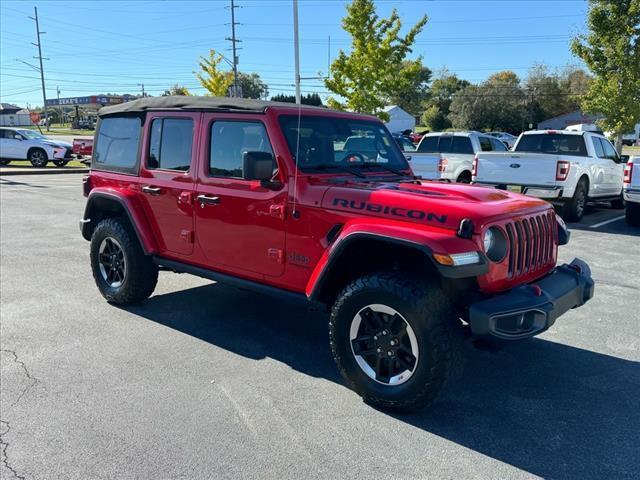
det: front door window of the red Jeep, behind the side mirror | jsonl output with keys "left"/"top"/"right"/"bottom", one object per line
{"left": 209, "top": 121, "right": 275, "bottom": 178}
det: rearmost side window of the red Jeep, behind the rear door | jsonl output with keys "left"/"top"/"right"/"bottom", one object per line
{"left": 93, "top": 117, "right": 141, "bottom": 172}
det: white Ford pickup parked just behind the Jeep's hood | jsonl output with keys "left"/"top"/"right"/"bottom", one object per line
{"left": 473, "top": 130, "right": 628, "bottom": 222}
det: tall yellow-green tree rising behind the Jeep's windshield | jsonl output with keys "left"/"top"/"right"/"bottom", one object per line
{"left": 325, "top": 0, "right": 427, "bottom": 120}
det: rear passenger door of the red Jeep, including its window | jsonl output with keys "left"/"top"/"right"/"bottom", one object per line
{"left": 140, "top": 112, "right": 201, "bottom": 256}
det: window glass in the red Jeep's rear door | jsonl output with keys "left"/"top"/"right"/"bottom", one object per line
{"left": 147, "top": 118, "right": 193, "bottom": 172}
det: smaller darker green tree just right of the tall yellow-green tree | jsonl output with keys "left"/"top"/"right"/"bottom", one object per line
{"left": 387, "top": 59, "right": 431, "bottom": 116}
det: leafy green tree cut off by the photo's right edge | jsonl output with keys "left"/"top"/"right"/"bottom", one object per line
{"left": 571, "top": 0, "right": 640, "bottom": 150}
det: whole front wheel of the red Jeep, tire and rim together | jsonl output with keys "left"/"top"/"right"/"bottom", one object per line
{"left": 329, "top": 271, "right": 461, "bottom": 412}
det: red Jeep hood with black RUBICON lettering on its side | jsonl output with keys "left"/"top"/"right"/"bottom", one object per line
{"left": 322, "top": 182, "right": 550, "bottom": 230}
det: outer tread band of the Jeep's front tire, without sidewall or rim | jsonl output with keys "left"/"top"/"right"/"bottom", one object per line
{"left": 329, "top": 270, "right": 463, "bottom": 413}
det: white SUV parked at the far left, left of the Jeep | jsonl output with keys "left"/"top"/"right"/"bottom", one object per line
{"left": 0, "top": 127, "right": 72, "bottom": 167}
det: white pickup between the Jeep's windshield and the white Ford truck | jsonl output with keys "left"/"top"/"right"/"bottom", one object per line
{"left": 411, "top": 132, "right": 507, "bottom": 183}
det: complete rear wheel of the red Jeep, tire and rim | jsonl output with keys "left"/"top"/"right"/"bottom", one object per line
{"left": 91, "top": 218, "right": 158, "bottom": 305}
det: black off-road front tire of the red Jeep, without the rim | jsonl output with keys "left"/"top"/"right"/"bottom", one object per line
{"left": 329, "top": 271, "right": 463, "bottom": 413}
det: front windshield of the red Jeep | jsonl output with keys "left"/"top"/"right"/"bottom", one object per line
{"left": 279, "top": 115, "right": 409, "bottom": 172}
